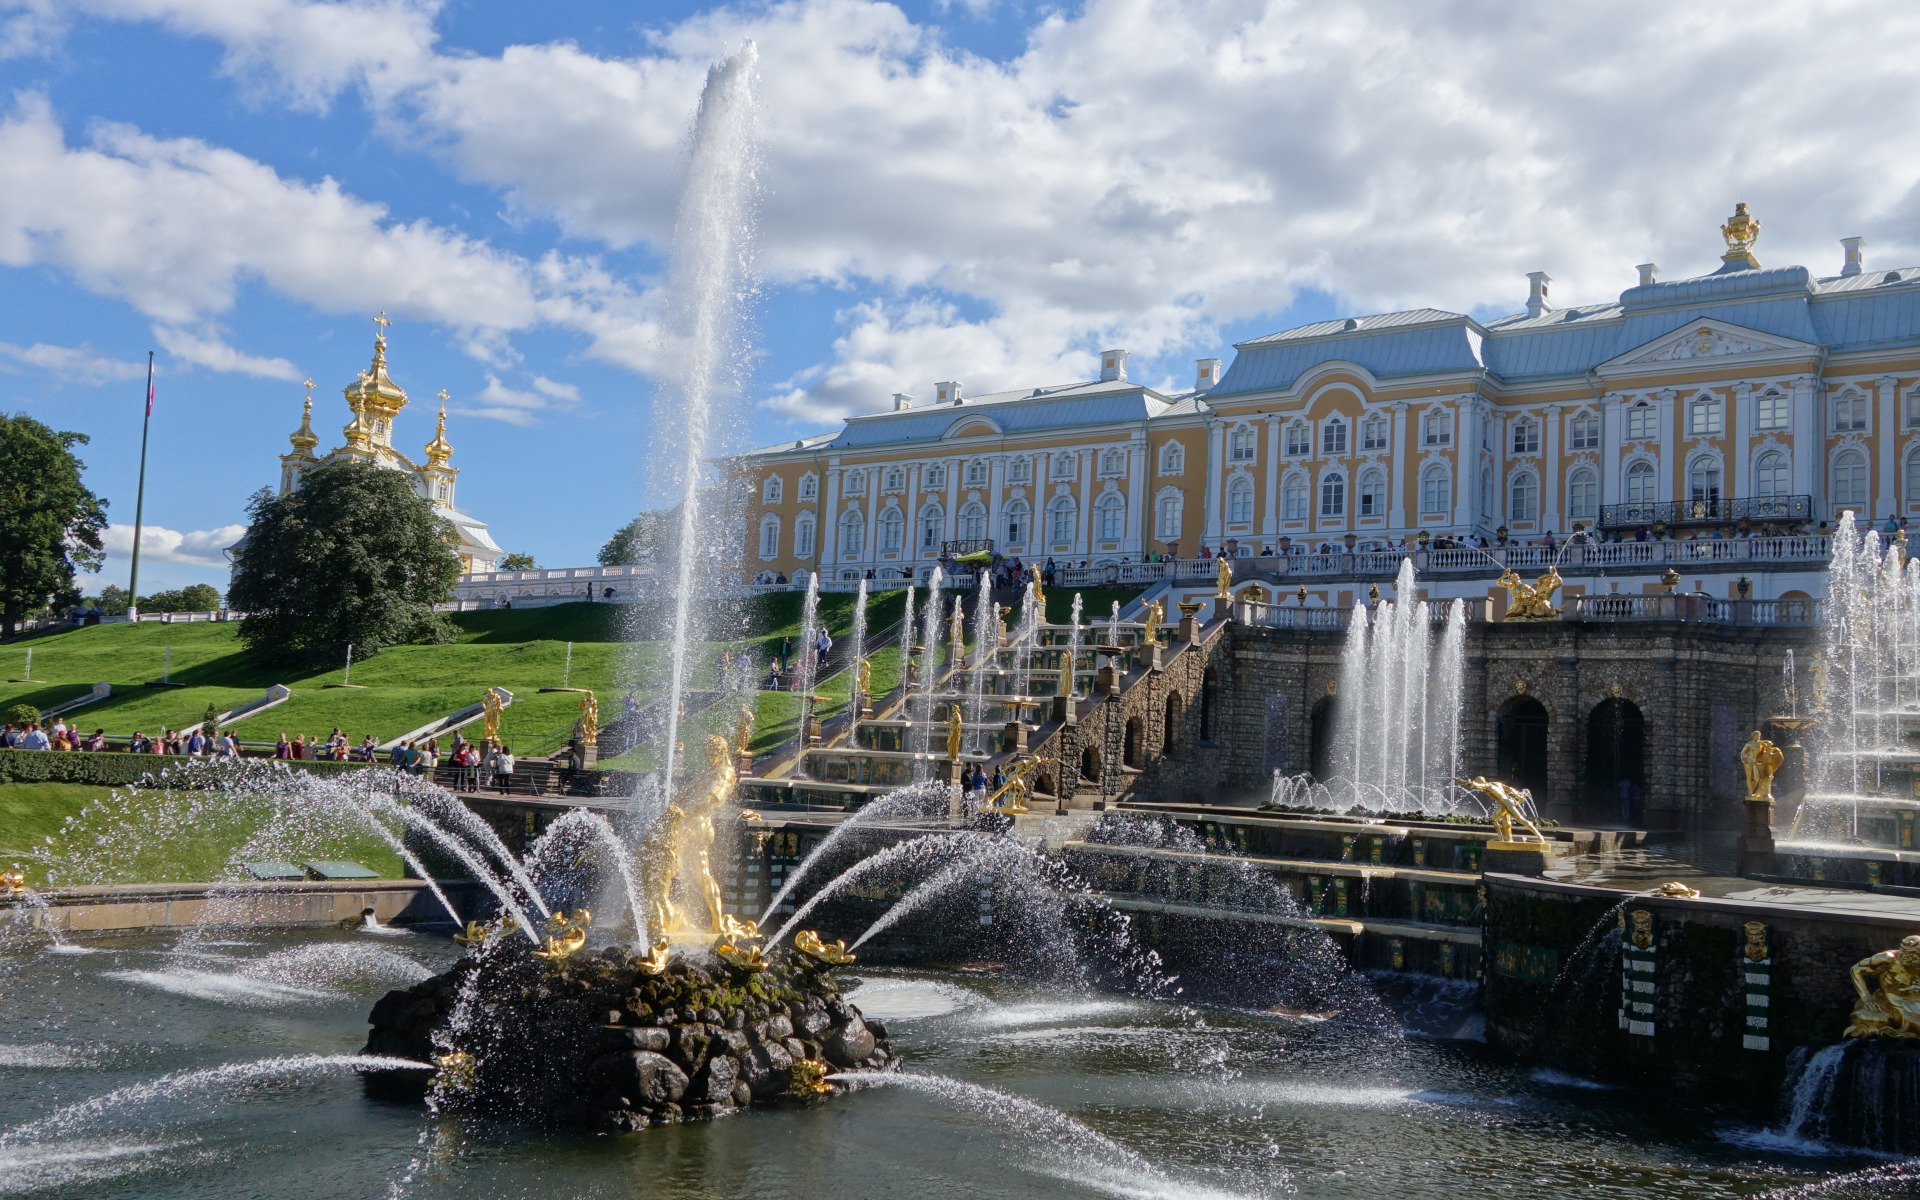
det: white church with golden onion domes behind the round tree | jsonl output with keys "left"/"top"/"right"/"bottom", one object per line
{"left": 280, "top": 313, "right": 503, "bottom": 572}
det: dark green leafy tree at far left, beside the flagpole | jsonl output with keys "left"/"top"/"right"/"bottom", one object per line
{"left": 0, "top": 413, "right": 108, "bottom": 634}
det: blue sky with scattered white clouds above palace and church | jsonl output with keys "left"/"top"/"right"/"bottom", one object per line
{"left": 0, "top": 0, "right": 1920, "bottom": 589}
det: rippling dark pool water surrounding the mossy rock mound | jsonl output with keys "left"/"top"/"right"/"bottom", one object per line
{"left": 0, "top": 931, "right": 1907, "bottom": 1200}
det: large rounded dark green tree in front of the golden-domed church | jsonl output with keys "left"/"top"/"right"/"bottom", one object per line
{"left": 227, "top": 463, "right": 461, "bottom": 666}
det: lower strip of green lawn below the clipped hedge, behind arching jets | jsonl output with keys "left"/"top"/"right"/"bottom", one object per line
{"left": 0, "top": 771, "right": 403, "bottom": 885}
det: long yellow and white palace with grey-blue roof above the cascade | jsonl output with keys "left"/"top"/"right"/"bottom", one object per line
{"left": 729, "top": 204, "right": 1920, "bottom": 595}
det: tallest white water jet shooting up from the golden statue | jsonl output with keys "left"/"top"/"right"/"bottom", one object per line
{"left": 649, "top": 42, "right": 758, "bottom": 797}
